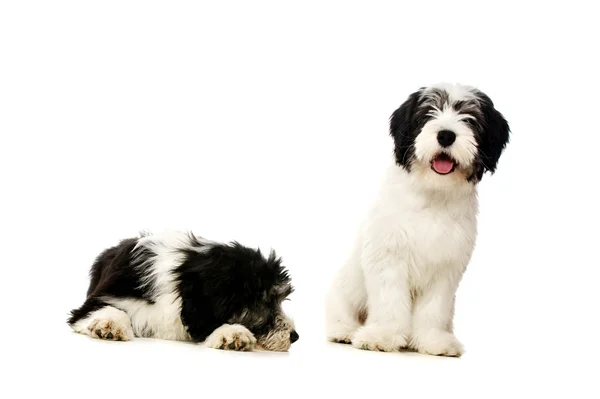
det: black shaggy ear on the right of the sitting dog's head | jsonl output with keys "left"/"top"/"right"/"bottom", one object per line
{"left": 479, "top": 93, "right": 510, "bottom": 173}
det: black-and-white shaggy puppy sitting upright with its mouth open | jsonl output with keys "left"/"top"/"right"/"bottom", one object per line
{"left": 325, "top": 84, "right": 511, "bottom": 356}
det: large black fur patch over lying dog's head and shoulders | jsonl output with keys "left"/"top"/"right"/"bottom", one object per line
{"left": 177, "top": 243, "right": 292, "bottom": 341}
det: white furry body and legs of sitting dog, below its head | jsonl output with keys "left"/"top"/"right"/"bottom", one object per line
{"left": 326, "top": 159, "right": 477, "bottom": 356}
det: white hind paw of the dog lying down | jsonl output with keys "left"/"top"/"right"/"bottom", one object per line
{"left": 70, "top": 305, "right": 134, "bottom": 341}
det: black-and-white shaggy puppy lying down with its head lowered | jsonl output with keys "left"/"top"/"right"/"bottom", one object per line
{"left": 67, "top": 231, "right": 299, "bottom": 351}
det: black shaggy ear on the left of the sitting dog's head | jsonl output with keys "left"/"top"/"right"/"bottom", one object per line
{"left": 390, "top": 90, "right": 421, "bottom": 169}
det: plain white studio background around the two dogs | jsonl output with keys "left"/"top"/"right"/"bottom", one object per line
{"left": 0, "top": 1, "right": 600, "bottom": 398}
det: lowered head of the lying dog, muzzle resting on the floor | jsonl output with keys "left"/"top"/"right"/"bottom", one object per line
{"left": 223, "top": 246, "right": 299, "bottom": 351}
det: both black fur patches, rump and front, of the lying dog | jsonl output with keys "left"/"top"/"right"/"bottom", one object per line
{"left": 68, "top": 234, "right": 293, "bottom": 342}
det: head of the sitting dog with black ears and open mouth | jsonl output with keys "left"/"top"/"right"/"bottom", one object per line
{"left": 390, "top": 84, "right": 510, "bottom": 188}
